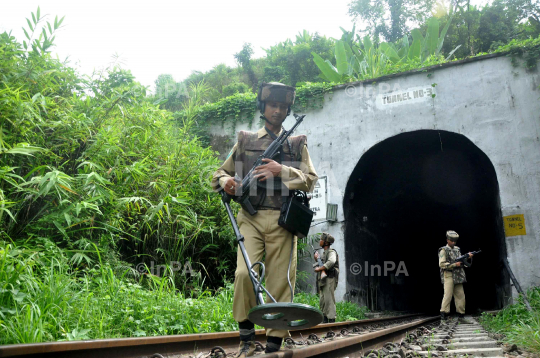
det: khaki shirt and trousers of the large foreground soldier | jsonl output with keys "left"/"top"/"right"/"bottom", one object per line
{"left": 212, "top": 128, "right": 318, "bottom": 338}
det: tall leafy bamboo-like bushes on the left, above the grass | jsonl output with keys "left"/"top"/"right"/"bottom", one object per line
{"left": 0, "top": 10, "right": 236, "bottom": 289}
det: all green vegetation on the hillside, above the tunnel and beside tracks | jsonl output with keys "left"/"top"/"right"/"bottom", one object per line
{"left": 0, "top": 0, "right": 540, "bottom": 347}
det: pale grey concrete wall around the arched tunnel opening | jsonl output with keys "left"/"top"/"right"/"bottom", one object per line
{"left": 211, "top": 56, "right": 540, "bottom": 309}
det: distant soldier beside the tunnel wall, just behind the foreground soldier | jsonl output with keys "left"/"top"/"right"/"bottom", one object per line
{"left": 313, "top": 232, "right": 339, "bottom": 323}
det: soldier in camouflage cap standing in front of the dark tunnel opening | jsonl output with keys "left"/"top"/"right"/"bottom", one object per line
{"left": 439, "top": 230, "right": 473, "bottom": 321}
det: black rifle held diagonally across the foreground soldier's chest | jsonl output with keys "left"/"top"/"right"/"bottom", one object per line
{"left": 221, "top": 114, "right": 306, "bottom": 215}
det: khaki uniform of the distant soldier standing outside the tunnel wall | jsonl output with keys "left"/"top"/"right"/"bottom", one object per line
{"left": 313, "top": 249, "right": 339, "bottom": 319}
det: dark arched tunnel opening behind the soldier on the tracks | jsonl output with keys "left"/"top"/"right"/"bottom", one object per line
{"left": 343, "top": 130, "right": 511, "bottom": 313}
